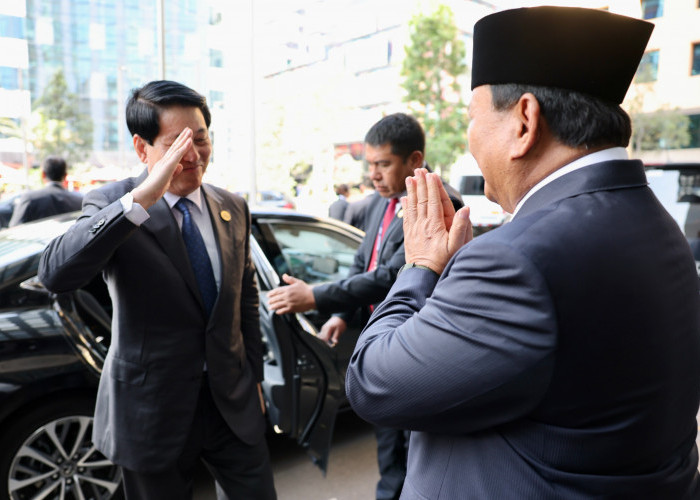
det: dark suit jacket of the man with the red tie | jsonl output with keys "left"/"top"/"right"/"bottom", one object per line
{"left": 313, "top": 183, "right": 463, "bottom": 322}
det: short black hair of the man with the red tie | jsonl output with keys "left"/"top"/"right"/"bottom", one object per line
{"left": 365, "top": 113, "right": 425, "bottom": 160}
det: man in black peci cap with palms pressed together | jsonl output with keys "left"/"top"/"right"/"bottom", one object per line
{"left": 346, "top": 7, "right": 700, "bottom": 500}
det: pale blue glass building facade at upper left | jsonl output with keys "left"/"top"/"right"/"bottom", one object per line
{"left": 0, "top": 0, "right": 221, "bottom": 162}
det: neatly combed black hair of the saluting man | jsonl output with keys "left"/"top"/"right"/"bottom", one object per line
{"left": 126, "top": 80, "right": 211, "bottom": 145}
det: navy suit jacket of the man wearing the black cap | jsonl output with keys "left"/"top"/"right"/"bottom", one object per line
{"left": 346, "top": 160, "right": 700, "bottom": 500}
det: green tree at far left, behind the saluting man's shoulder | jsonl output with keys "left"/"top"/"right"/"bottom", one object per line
{"left": 32, "top": 69, "right": 92, "bottom": 163}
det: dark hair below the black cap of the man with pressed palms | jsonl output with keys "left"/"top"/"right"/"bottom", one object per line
{"left": 491, "top": 83, "right": 632, "bottom": 149}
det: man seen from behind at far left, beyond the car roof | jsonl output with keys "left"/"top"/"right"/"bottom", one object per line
{"left": 9, "top": 156, "right": 83, "bottom": 227}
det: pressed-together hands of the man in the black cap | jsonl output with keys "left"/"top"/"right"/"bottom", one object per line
{"left": 401, "top": 168, "right": 473, "bottom": 274}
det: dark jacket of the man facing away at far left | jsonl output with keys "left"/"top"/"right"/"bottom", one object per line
{"left": 9, "top": 182, "right": 83, "bottom": 227}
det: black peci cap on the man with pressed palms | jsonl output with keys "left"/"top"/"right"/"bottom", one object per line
{"left": 472, "top": 7, "right": 654, "bottom": 104}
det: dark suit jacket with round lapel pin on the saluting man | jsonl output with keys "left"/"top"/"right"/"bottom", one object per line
{"left": 39, "top": 172, "right": 265, "bottom": 472}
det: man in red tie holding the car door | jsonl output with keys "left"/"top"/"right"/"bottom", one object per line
{"left": 268, "top": 113, "right": 462, "bottom": 500}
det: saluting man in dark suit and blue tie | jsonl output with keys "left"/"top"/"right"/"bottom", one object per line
{"left": 39, "top": 81, "right": 275, "bottom": 500}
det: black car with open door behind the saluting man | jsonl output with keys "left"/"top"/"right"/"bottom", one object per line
{"left": 0, "top": 211, "right": 363, "bottom": 500}
